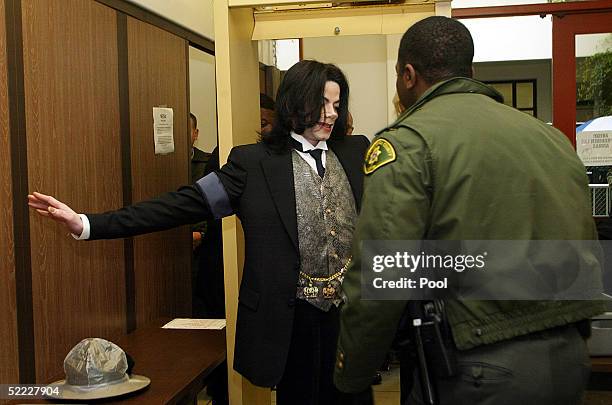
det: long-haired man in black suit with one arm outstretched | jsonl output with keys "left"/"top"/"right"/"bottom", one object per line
{"left": 28, "top": 60, "right": 369, "bottom": 405}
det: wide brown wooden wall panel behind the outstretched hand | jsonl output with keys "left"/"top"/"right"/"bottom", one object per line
{"left": 22, "top": 0, "right": 126, "bottom": 381}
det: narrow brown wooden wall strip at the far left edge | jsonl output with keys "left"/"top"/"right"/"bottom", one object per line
{"left": 0, "top": 0, "right": 19, "bottom": 384}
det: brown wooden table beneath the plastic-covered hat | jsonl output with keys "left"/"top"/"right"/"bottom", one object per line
{"left": 11, "top": 319, "right": 226, "bottom": 405}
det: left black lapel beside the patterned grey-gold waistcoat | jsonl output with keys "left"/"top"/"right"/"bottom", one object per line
{"left": 261, "top": 151, "right": 299, "bottom": 251}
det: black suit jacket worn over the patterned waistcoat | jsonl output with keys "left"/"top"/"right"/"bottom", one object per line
{"left": 88, "top": 136, "right": 368, "bottom": 387}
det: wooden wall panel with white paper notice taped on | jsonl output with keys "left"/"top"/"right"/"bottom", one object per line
{"left": 127, "top": 17, "right": 191, "bottom": 326}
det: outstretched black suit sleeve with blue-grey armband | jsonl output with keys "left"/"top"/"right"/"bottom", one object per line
{"left": 86, "top": 145, "right": 246, "bottom": 240}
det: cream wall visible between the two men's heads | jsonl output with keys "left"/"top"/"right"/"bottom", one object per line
{"left": 303, "top": 35, "right": 388, "bottom": 138}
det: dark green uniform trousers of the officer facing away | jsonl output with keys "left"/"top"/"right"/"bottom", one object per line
{"left": 407, "top": 325, "right": 591, "bottom": 405}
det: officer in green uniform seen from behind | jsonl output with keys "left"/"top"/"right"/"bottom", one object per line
{"left": 335, "top": 17, "right": 604, "bottom": 405}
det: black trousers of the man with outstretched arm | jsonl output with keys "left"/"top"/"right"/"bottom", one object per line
{"left": 276, "top": 299, "right": 340, "bottom": 405}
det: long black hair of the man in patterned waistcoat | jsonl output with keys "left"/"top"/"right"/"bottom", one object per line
{"left": 261, "top": 60, "right": 349, "bottom": 150}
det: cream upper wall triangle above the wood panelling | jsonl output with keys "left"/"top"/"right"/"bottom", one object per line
{"left": 128, "top": 0, "right": 215, "bottom": 40}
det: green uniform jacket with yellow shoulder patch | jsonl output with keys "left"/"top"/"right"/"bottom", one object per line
{"left": 335, "top": 78, "right": 604, "bottom": 392}
